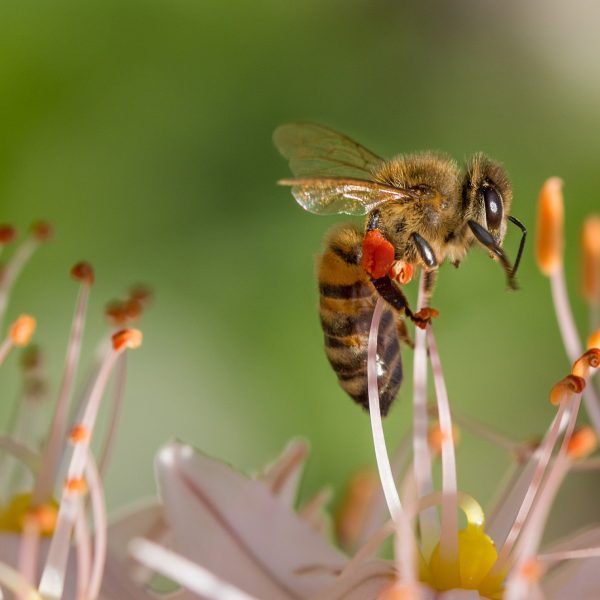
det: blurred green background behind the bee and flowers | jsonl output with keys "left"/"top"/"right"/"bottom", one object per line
{"left": 0, "top": 0, "right": 600, "bottom": 530}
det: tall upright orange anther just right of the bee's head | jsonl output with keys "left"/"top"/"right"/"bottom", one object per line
{"left": 536, "top": 177, "right": 564, "bottom": 275}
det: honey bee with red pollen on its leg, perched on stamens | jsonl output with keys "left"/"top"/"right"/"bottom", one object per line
{"left": 273, "top": 123, "right": 527, "bottom": 415}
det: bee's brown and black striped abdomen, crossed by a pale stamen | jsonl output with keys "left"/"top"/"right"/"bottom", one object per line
{"left": 318, "top": 225, "right": 402, "bottom": 415}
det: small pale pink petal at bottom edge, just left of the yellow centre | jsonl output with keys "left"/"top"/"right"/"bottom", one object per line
{"left": 311, "top": 560, "right": 395, "bottom": 600}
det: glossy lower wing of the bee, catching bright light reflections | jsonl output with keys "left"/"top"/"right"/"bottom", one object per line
{"left": 279, "top": 177, "right": 415, "bottom": 215}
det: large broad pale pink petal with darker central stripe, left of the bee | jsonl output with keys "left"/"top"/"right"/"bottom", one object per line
{"left": 157, "top": 443, "right": 346, "bottom": 600}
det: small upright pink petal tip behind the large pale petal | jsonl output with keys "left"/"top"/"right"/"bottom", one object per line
{"left": 257, "top": 439, "right": 308, "bottom": 507}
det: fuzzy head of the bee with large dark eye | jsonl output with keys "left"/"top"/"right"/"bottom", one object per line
{"left": 462, "top": 154, "right": 512, "bottom": 246}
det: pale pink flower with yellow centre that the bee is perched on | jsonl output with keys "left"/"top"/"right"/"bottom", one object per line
{"left": 122, "top": 179, "right": 600, "bottom": 600}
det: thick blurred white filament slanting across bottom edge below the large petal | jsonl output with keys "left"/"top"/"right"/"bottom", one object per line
{"left": 129, "top": 538, "right": 257, "bottom": 600}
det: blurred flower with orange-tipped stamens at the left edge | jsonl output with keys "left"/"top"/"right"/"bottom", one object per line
{"left": 0, "top": 222, "right": 142, "bottom": 600}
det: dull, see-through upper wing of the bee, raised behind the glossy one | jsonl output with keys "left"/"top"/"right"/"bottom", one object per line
{"left": 273, "top": 123, "right": 383, "bottom": 179}
